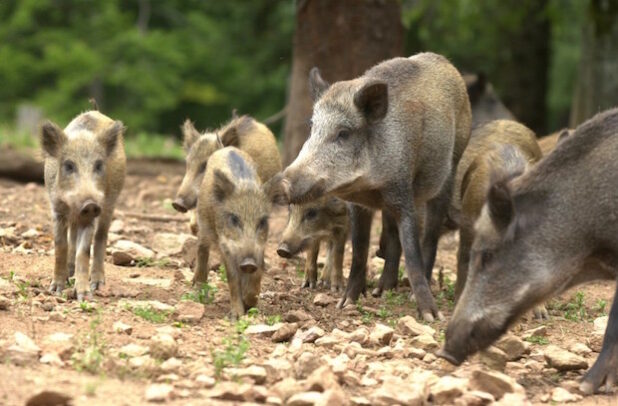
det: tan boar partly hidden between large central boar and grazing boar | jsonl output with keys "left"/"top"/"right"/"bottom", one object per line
{"left": 451, "top": 120, "right": 541, "bottom": 298}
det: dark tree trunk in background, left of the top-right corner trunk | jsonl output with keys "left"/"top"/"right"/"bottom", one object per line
{"left": 497, "top": 0, "right": 550, "bottom": 134}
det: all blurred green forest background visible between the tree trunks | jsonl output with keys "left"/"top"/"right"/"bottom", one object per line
{"left": 0, "top": 0, "right": 594, "bottom": 154}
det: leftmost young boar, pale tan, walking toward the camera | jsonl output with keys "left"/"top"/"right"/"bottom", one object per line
{"left": 40, "top": 111, "right": 126, "bottom": 301}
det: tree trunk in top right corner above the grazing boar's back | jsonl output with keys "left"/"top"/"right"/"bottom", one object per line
{"left": 569, "top": 0, "right": 618, "bottom": 128}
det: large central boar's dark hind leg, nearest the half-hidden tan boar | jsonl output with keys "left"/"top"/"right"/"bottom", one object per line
{"left": 421, "top": 176, "right": 453, "bottom": 281}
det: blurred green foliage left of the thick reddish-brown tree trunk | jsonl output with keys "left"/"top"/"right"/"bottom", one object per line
{"left": 0, "top": 0, "right": 294, "bottom": 136}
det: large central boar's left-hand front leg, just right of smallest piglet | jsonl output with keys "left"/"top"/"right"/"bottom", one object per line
{"left": 337, "top": 205, "right": 373, "bottom": 309}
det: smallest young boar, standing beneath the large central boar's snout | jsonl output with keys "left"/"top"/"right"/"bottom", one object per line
{"left": 277, "top": 197, "right": 348, "bottom": 292}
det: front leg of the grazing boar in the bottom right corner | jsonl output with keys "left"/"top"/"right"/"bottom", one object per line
{"left": 579, "top": 281, "right": 618, "bottom": 394}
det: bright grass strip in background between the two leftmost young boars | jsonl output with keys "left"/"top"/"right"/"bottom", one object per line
{"left": 124, "top": 133, "right": 185, "bottom": 160}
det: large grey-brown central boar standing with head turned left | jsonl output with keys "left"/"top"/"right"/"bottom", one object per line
{"left": 283, "top": 53, "right": 470, "bottom": 320}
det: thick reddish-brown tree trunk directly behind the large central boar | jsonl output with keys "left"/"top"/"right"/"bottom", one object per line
{"left": 283, "top": 0, "right": 404, "bottom": 165}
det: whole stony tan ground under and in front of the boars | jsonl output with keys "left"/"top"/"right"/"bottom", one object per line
{"left": 0, "top": 162, "right": 618, "bottom": 406}
